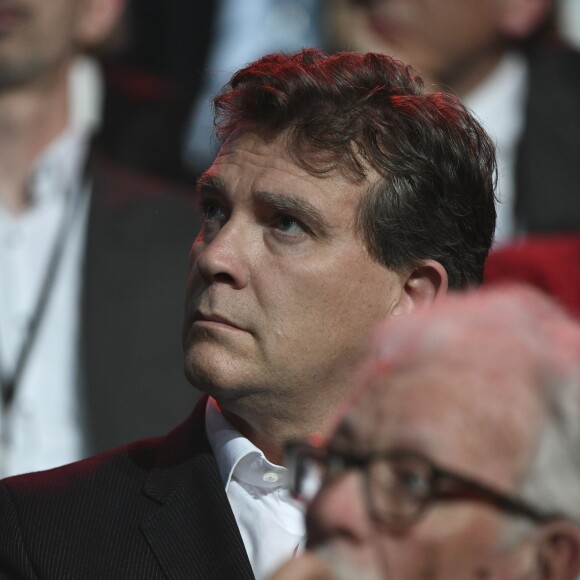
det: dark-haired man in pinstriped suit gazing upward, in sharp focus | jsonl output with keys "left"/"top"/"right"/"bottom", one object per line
{"left": 0, "top": 51, "right": 495, "bottom": 579}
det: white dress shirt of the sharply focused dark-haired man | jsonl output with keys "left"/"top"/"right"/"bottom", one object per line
{"left": 205, "top": 397, "right": 305, "bottom": 580}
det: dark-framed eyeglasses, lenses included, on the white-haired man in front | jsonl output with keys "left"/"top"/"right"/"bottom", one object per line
{"left": 285, "top": 443, "right": 569, "bottom": 527}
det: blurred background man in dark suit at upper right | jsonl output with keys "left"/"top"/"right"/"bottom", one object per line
{"left": 324, "top": 0, "right": 580, "bottom": 243}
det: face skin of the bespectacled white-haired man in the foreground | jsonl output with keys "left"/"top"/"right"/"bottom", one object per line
{"left": 308, "top": 363, "right": 539, "bottom": 580}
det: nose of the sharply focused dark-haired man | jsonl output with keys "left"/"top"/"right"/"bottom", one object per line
{"left": 192, "top": 222, "right": 249, "bottom": 289}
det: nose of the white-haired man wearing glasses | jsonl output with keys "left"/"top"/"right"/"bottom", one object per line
{"left": 306, "top": 472, "right": 371, "bottom": 548}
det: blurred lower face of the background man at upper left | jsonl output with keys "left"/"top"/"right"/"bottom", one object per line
{"left": 0, "top": 0, "right": 86, "bottom": 87}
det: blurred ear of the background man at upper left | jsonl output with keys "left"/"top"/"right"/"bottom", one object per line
{"left": 76, "top": 0, "right": 125, "bottom": 49}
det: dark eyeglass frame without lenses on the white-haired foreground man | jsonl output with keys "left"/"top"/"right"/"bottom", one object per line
{"left": 284, "top": 441, "right": 568, "bottom": 527}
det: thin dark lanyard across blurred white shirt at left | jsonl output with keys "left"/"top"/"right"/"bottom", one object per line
{"left": 0, "top": 163, "right": 89, "bottom": 414}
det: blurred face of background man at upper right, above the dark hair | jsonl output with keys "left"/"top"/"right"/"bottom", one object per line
{"left": 328, "top": 0, "right": 505, "bottom": 89}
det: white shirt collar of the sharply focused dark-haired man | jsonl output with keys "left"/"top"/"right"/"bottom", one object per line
{"left": 205, "top": 397, "right": 288, "bottom": 491}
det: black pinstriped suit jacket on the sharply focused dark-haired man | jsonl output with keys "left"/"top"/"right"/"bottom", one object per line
{"left": 0, "top": 399, "right": 254, "bottom": 580}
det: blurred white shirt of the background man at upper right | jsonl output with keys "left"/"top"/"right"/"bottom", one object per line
{"left": 464, "top": 52, "right": 528, "bottom": 245}
